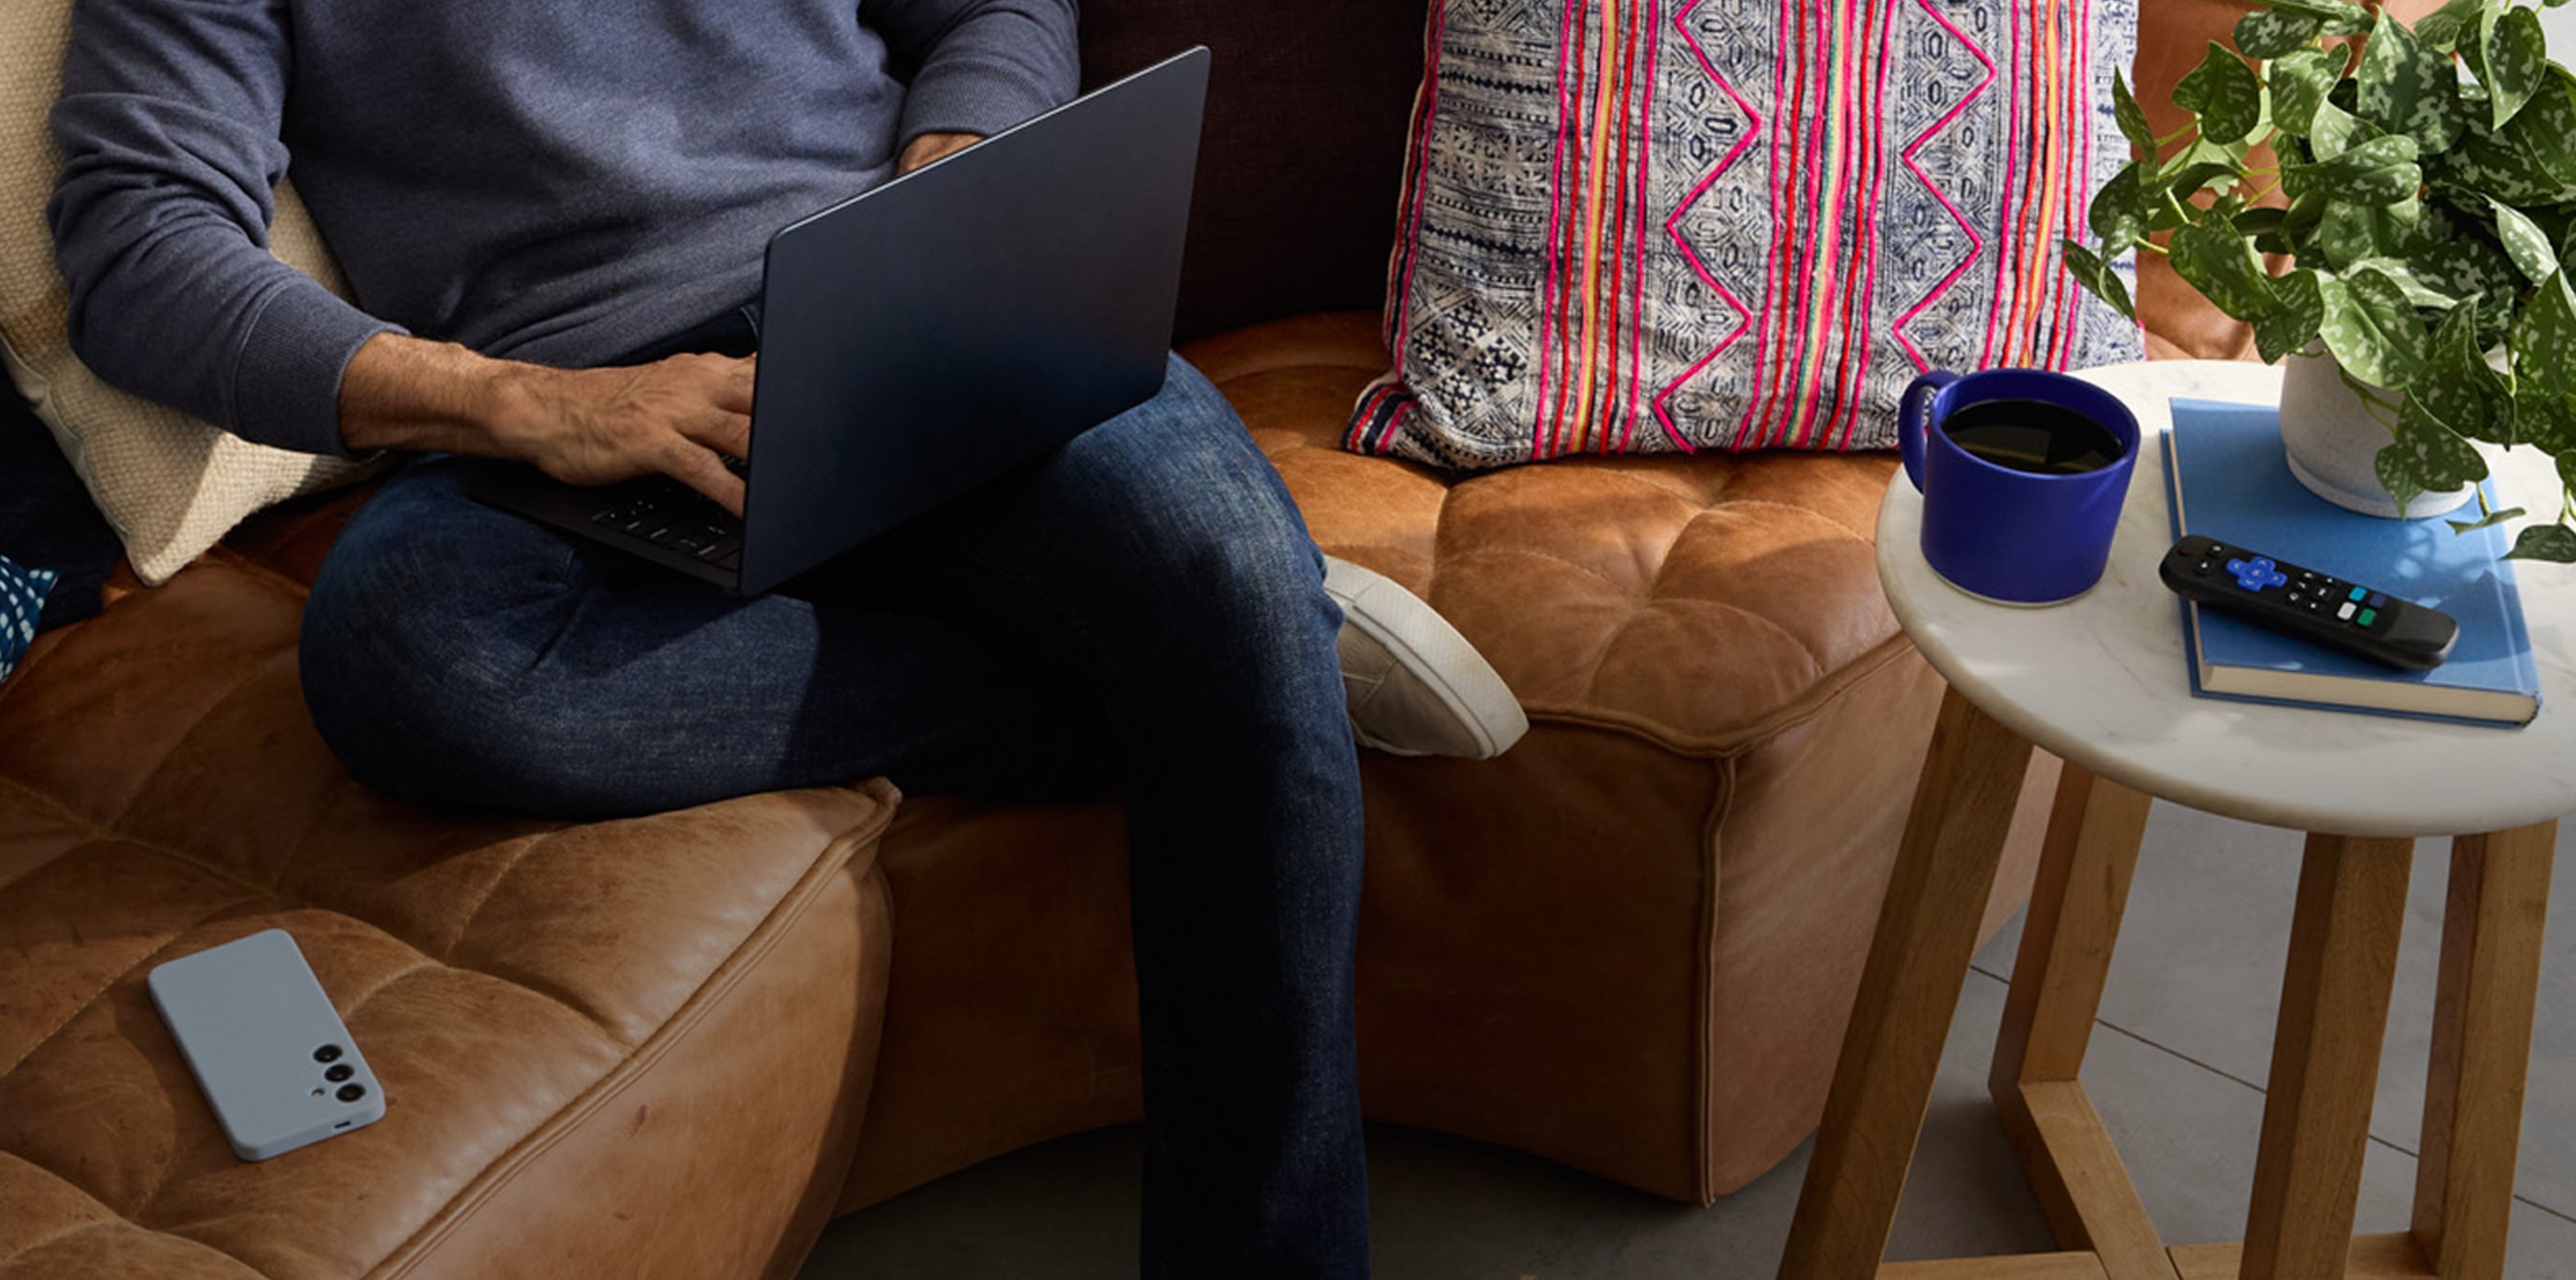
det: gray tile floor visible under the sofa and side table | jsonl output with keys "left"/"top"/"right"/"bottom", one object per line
{"left": 802, "top": 806, "right": 2576, "bottom": 1280}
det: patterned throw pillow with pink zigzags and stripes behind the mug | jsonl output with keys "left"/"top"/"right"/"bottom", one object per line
{"left": 1345, "top": 0, "right": 2140, "bottom": 469}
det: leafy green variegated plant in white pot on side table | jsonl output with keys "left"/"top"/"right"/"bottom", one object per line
{"left": 2066, "top": 0, "right": 2576, "bottom": 564}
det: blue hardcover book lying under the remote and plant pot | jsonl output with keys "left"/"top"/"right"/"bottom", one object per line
{"left": 2164, "top": 400, "right": 2540, "bottom": 726}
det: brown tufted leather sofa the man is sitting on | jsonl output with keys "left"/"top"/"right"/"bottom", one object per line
{"left": 0, "top": 0, "right": 2297, "bottom": 1278}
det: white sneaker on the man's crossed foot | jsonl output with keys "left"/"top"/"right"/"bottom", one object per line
{"left": 1324, "top": 556, "right": 1530, "bottom": 760}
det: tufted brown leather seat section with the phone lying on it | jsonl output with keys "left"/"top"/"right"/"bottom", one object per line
{"left": 0, "top": 561, "right": 894, "bottom": 1278}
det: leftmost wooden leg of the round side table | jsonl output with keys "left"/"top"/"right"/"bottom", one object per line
{"left": 1780, "top": 690, "right": 2030, "bottom": 1280}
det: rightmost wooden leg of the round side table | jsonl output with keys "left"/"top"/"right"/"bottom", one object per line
{"left": 2414, "top": 821, "right": 2558, "bottom": 1280}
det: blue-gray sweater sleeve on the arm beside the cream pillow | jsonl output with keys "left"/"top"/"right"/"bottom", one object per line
{"left": 47, "top": 0, "right": 397, "bottom": 456}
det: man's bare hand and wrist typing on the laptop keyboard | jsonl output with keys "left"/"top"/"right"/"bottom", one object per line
{"left": 340, "top": 335, "right": 755, "bottom": 515}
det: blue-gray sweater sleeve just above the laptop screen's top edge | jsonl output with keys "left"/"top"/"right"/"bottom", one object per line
{"left": 863, "top": 0, "right": 1080, "bottom": 147}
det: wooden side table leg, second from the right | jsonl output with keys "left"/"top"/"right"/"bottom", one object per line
{"left": 2239, "top": 834, "right": 2414, "bottom": 1280}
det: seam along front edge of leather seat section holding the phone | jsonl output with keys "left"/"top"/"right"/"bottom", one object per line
{"left": 366, "top": 785, "right": 899, "bottom": 1280}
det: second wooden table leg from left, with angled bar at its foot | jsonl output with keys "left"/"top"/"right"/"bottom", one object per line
{"left": 1989, "top": 765, "right": 2174, "bottom": 1280}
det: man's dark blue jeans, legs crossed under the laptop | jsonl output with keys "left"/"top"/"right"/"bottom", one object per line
{"left": 301, "top": 342, "right": 1368, "bottom": 1280}
